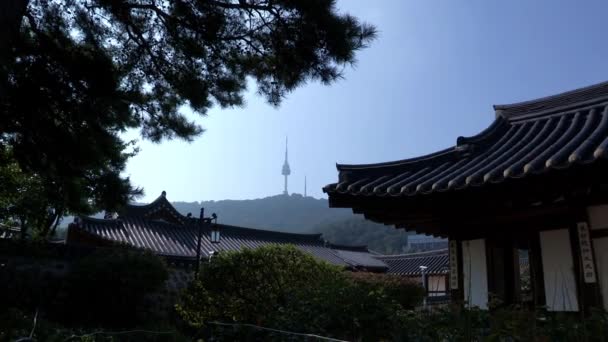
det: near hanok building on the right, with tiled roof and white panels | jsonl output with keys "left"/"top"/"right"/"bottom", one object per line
{"left": 324, "top": 82, "right": 608, "bottom": 311}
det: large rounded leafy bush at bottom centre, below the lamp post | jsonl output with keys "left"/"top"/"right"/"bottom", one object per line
{"left": 178, "top": 246, "right": 422, "bottom": 340}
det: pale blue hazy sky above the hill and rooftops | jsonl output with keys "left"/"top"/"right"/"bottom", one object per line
{"left": 127, "top": 0, "right": 608, "bottom": 201}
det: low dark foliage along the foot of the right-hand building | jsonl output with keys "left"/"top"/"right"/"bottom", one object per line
{"left": 398, "top": 306, "right": 608, "bottom": 342}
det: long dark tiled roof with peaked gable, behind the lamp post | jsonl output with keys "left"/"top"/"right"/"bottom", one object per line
{"left": 66, "top": 191, "right": 388, "bottom": 272}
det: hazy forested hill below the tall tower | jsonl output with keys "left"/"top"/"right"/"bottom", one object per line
{"left": 172, "top": 194, "right": 407, "bottom": 254}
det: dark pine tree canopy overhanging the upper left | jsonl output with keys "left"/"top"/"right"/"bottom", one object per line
{"left": 0, "top": 0, "right": 375, "bottom": 235}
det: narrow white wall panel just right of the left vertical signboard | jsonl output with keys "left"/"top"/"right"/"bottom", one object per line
{"left": 462, "top": 239, "right": 488, "bottom": 309}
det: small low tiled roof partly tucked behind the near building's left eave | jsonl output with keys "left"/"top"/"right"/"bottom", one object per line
{"left": 375, "top": 249, "right": 449, "bottom": 276}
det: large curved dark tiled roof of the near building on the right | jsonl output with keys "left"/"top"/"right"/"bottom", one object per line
{"left": 323, "top": 83, "right": 608, "bottom": 197}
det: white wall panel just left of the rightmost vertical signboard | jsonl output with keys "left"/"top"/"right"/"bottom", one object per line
{"left": 540, "top": 229, "right": 578, "bottom": 311}
